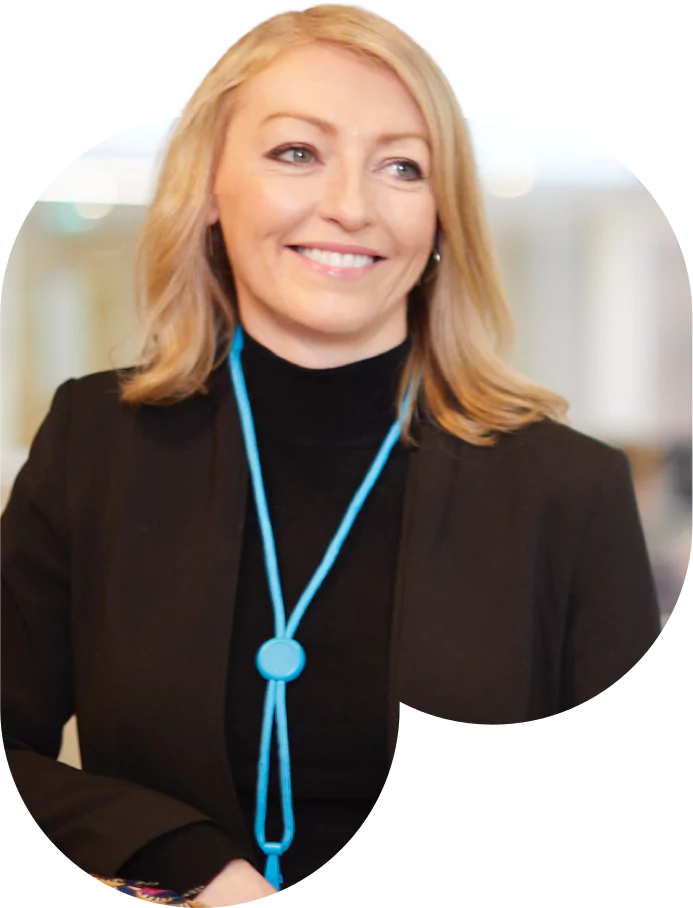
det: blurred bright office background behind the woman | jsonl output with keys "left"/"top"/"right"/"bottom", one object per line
{"left": 0, "top": 0, "right": 693, "bottom": 768}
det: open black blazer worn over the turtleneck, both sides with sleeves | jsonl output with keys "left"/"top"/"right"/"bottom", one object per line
{"left": 0, "top": 363, "right": 662, "bottom": 876}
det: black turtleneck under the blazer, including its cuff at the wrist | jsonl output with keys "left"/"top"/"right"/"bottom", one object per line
{"left": 120, "top": 331, "right": 410, "bottom": 892}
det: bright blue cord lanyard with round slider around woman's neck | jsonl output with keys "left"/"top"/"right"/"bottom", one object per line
{"left": 229, "top": 321, "right": 413, "bottom": 890}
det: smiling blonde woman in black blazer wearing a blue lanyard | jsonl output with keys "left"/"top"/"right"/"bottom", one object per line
{"left": 0, "top": 4, "right": 660, "bottom": 908}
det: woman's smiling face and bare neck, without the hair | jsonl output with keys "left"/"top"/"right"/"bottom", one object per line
{"left": 208, "top": 44, "right": 436, "bottom": 368}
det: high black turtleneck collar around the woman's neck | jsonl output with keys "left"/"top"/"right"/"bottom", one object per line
{"left": 235, "top": 329, "right": 411, "bottom": 445}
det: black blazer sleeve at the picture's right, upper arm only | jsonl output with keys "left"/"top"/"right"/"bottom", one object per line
{"left": 563, "top": 448, "right": 663, "bottom": 711}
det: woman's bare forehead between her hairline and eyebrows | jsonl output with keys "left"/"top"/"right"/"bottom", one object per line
{"left": 239, "top": 42, "right": 427, "bottom": 132}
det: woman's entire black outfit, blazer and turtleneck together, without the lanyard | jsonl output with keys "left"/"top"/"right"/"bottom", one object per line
{"left": 0, "top": 332, "right": 661, "bottom": 892}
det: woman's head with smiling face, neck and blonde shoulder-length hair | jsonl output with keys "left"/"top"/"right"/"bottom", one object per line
{"left": 119, "top": 3, "right": 569, "bottom": 447}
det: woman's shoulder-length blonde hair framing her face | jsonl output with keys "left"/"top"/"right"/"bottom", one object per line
{"left": 116, "top": 3, "right": 569, "bottom": 447}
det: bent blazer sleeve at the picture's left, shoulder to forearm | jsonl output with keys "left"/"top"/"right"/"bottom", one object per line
{"left": 0, "top": 379, "right": 252, "bottom": 888}
